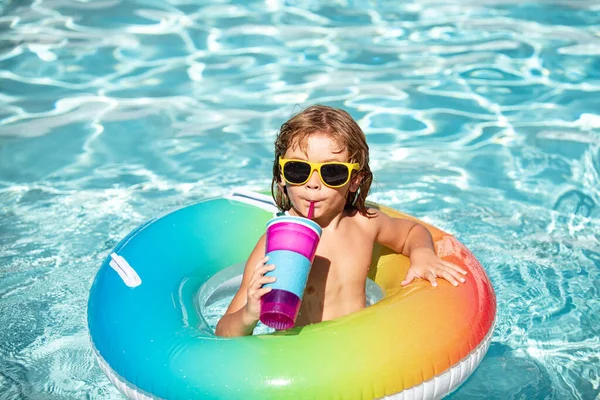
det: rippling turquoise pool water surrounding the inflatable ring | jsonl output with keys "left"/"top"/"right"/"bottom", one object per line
{"left": 0, "top": 0, "right": 600, "bottom": 399}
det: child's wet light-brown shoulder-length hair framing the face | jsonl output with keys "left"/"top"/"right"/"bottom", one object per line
{"left": 271, "top": 105, "right": 373, "bottom": 216}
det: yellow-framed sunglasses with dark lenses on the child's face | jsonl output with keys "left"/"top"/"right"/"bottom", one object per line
{"left": 279, "top": 157, "right": 360, "bottom": 188}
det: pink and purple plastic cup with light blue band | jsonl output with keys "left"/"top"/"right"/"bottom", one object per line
{"left": 260, "top": 216, "right": 321, "bottom": 330}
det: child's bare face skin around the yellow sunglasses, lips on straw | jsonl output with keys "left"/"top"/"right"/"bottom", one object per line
{"left": 279, "top": 134, "right": 360, "bottom": 218}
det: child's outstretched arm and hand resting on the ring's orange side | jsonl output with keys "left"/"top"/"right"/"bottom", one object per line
{"left": 375, "top": 212, "right": 467, "bottom": 286}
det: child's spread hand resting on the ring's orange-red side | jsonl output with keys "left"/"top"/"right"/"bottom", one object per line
{"left": 401, "top": 248, "right": 467, "bottom": 286}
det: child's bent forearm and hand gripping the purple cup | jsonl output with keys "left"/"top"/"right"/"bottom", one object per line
{"left": 215, "top": 235, "right": 275, "bottom": 337}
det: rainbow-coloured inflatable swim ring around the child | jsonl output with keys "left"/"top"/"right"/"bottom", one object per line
{"left": 88, "top": 193, "right": 496, "bottom": 400}
